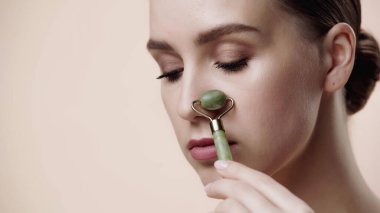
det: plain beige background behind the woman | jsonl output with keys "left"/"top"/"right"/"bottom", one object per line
{"left": 0, "top": 0, "right": 380, "bottom": 213}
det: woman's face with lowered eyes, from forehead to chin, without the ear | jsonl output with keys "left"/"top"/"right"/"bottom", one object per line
{"left": 148, "top": 0, "right": 323, "bottom": 184}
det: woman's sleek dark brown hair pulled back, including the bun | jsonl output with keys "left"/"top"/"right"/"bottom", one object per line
{"left": 278, "top": 0, "right": 380, "bottom": 114}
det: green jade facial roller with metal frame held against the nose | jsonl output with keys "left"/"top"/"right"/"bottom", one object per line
{"left": 191, "top": 90, "right": 234, "bottom": 160}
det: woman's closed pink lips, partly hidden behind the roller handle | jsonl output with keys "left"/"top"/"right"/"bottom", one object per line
{"left": 187, "top": 138, "right": 236, "bottom": 160}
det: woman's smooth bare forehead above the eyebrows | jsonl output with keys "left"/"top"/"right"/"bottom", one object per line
{"left": 150, "top": 0, "right": 279, "bottom": 40}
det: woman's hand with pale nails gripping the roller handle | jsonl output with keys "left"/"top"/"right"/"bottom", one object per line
{"left": 205, "top": 161, "right": 314, "bottom": 213}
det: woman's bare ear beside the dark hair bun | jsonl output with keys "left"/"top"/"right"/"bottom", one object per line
{"left": 323, "top": 23, "right": 356, "bottom": 92}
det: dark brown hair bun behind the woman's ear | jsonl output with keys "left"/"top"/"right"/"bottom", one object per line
{"left": 345, "top": 30, "right": 380, "bottom": 114}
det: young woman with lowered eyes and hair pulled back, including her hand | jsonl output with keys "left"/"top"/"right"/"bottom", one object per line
{"left": 147, "top": 0, "right": 380, "bottom": 212}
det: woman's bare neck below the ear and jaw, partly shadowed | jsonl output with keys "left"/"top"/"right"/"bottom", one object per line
{"left": 273, "top": 93, "right": 380, "bottom": 212}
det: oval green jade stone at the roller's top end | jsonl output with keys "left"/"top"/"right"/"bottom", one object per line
{"left": 200, "top": 90, "right": 227, "bottom": 110}
